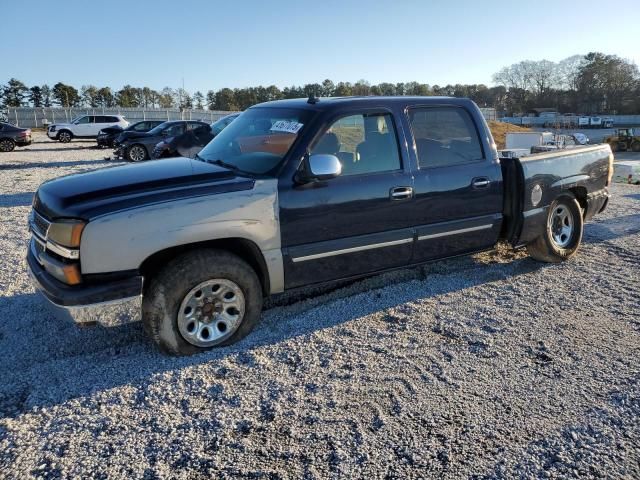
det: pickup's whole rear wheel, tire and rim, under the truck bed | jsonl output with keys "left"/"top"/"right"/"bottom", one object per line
{"left": 527, "top": 193, "right": 584, "bottom": 263}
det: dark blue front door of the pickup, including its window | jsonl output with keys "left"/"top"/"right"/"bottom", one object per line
{"left": 279, "top": 110, "right": 413, "bottom": 288}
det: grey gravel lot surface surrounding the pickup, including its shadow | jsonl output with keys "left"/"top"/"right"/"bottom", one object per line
{"left": 0, "top": 136, "right": 640, "bottom": 478}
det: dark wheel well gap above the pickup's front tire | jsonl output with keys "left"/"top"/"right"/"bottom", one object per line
{"left": 139, "top": 238, "right": 270, "bottom": 296}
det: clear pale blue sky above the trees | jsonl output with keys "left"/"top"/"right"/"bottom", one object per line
{"left": 0, "top": 0, "right": 640, "bottom": 93}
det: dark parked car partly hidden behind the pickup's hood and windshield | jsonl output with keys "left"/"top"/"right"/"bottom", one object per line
{"left": 151, "top": 113, "right": 240, "bottom": 158}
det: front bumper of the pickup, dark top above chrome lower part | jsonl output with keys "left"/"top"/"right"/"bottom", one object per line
{"left": 27, "top": 244, "right": 142, "bottom": 325}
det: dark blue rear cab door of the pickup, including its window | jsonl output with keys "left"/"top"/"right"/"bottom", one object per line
{"left": 407, "top": 106, "right": 503, "bottom": 262}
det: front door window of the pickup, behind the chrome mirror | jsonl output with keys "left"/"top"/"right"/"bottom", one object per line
{"left": 311, "top": 112, "right": 402, "bottom": 176}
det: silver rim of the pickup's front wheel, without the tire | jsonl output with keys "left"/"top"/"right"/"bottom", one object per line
{"left": 178, "top": 278, "right": 245, "bottom": 348}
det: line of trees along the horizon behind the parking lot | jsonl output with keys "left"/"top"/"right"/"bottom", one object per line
{"left": 0, "top": 52, "right": 640, "bottom": 114}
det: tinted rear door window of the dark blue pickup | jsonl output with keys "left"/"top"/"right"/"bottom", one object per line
{"left": 409, "top": 107, "right": 484, "bottom": 168}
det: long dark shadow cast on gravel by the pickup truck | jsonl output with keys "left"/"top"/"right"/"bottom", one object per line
{"left": 0, "top": 253, "right": 544, "bottom": 418}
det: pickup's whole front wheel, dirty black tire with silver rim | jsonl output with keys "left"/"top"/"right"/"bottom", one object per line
{"left": 142, "top": 249, "right": 262, "bottom": 355}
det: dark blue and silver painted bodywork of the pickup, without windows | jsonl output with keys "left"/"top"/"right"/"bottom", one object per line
{"left": 27, "top": 97, "right": 611, "bottom": 324}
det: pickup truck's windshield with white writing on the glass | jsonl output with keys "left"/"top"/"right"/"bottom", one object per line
{"left": 198, "top": 108, "right": 311, "bottom": 175}
